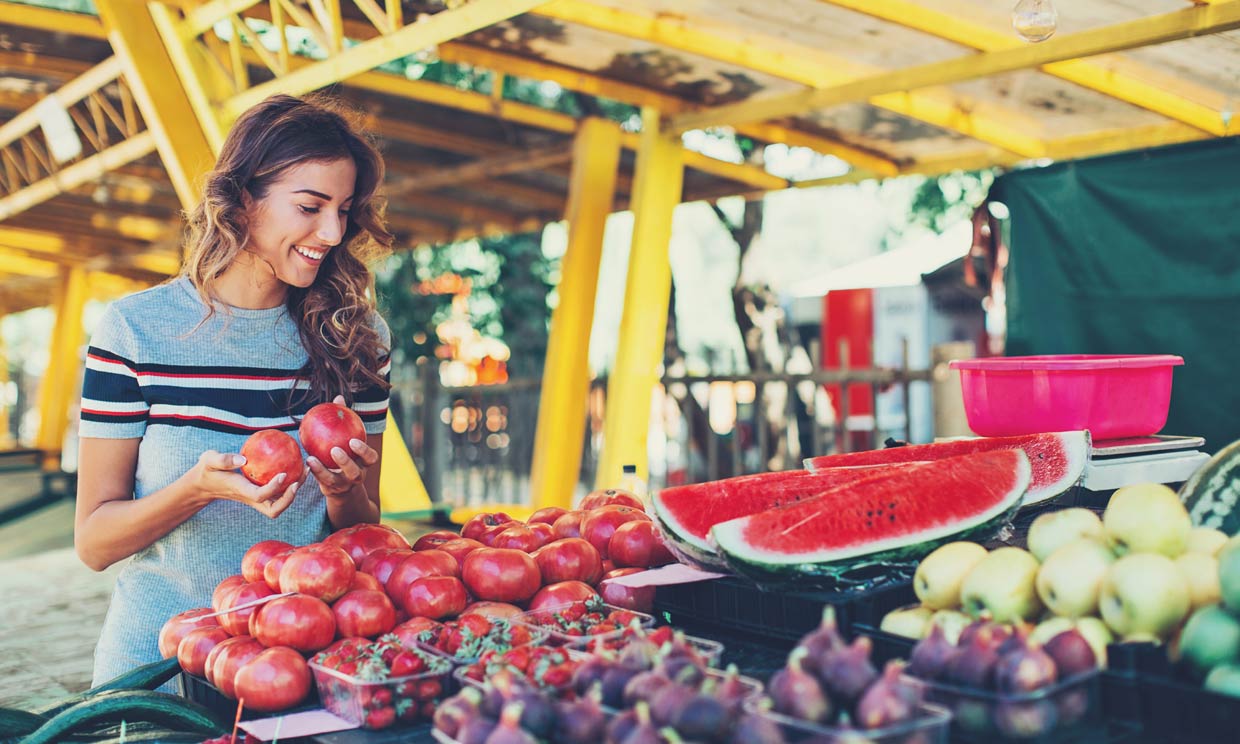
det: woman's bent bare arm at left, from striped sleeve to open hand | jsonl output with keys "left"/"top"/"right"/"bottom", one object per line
{"left": 73, "top": 438, "right": 298, "bottom": 570}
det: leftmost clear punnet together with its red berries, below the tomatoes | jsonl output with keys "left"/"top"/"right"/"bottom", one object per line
{"left": 310, "top": 635, "right": 453, "bottom": 729}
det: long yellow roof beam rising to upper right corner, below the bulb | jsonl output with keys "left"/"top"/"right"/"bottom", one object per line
{"left": 668, "top": 0, "right": 1240, "bottom": 131}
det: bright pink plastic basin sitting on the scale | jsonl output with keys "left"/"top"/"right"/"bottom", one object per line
{"left": 951, "top": 355, "right": 1184, "bottom": 439}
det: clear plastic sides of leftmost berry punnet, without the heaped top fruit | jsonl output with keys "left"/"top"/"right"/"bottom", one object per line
{"left": 309, "top": 650, "right": 455, "bottom": 730}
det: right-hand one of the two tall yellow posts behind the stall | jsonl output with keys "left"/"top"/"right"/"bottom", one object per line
{"left": 595, "top": 108, "right": 684, "bottom": 487}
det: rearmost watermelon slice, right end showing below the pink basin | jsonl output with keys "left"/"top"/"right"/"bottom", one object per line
{"left": 805, "top": 432, "right": 1090, "bottom": 505}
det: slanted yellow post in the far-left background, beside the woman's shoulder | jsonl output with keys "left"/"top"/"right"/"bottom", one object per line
{"left": 36, "top": 267, "right": 88, "bottom": 470}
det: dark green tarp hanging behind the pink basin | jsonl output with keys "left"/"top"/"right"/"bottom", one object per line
{"left": 991, "top": 138, "right": 1240, "bottom": 451}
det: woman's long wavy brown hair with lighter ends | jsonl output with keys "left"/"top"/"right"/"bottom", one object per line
{"left": 182, "top": 94, "right": 393, "bottom": 405}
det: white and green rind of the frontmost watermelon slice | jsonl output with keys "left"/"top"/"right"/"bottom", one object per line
{"left": 711, "top": 451, "right": 1032, "bottom": 588}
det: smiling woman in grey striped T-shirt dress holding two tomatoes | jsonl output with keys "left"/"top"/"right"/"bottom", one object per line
{"left": 74, "top": 95, "right": 392, "bottom": 683}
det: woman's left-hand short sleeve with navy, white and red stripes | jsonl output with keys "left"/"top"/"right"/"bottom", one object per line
{"left": 78, "top": 306, "right": 150, "bottom": 439}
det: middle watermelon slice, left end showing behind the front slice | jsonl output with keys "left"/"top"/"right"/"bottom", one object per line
{"left": 651, "top": 464, "right": 908, "bottom": 569}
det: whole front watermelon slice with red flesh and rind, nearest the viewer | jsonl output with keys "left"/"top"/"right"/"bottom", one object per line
{"left": 711, "top": 450, "right": 1032, "bottom": 585}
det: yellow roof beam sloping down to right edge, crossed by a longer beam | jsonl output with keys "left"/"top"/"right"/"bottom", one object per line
{"left": 821, "top": 0, "right": 1228, "bottom": 136}
